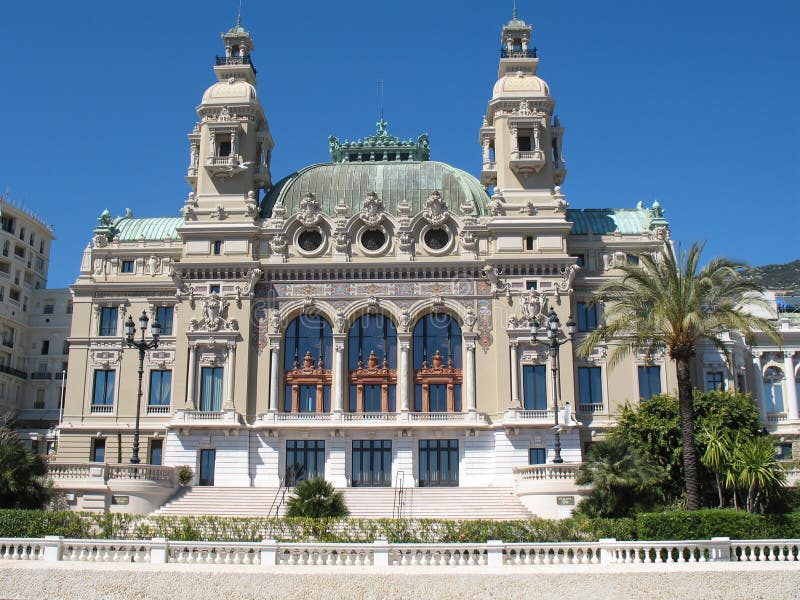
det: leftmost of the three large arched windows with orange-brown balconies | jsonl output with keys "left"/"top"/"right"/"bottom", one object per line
{"left": 284, "top": 315, "right": 333, "bottom": 413}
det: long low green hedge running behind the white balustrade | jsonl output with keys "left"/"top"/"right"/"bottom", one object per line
{"left": 0, "top": 509, "right": 800, "bottom": 543}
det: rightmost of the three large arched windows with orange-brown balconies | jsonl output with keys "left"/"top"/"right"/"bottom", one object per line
{"left": 414, "top": 314, "right": 463, "bottom": 412}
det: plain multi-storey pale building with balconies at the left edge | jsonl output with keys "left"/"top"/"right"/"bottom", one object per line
{"left": 0, "top": 198, "right": 72, "bottom": 453}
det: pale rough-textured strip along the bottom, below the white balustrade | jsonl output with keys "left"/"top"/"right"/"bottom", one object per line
{"left": 0, "top": 561, "right": 800, "bottom": 600}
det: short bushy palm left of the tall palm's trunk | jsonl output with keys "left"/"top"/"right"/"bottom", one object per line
{"left": 575, "top": 436, "right": 665, "bottom": 517}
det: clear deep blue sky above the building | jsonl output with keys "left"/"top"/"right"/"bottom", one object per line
{"left": 0, "top": 0, "right": 800, "bottom": 287}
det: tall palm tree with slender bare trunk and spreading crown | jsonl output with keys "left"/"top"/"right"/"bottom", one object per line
{"left": 578, "top": 243, "right": 780, "bottom": 510}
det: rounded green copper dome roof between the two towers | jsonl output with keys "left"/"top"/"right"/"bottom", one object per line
{"left": 261, "top": 161, "right": 489, "bottom": 217}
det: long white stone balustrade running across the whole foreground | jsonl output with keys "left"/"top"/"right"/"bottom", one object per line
{"left": 0, "top": 536, "right": 800, "bottom": 569}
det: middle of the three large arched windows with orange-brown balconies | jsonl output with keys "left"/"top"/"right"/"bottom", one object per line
{"left": 348, "top": 315, "right": 397, "bottom": 413}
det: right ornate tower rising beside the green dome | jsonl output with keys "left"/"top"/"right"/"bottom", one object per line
{"left": 480, "top": 9, "right": 566, "bottom": 214}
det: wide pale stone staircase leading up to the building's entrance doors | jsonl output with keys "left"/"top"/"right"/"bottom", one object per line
{"left": 153, "top": 487, "right": 533, "bottom": 520}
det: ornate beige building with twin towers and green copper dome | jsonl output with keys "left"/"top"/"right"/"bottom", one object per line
{"left": 57, "top": 18, "right": 692, "bottom": 494}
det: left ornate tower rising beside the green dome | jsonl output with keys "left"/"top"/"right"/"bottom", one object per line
{"left": 182, "top": 19, "right": 274, "bottom": 223}
